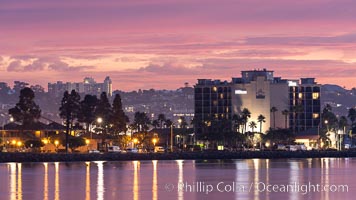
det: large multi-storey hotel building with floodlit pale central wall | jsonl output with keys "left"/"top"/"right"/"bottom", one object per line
{"left": 194, "top": 69, "right": 320, "bottom": 139}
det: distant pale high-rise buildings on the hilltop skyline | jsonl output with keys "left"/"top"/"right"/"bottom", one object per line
{"left": 48, "top": 76, "right": 112, "bottom": 97}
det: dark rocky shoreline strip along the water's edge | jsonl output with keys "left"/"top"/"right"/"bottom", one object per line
{"left": 0, "top": 151, "right": 356, "bottom": 163}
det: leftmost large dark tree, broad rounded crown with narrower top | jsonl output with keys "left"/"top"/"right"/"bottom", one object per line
{"left": 9, "top": 87, "right": 41, "bottom": 129}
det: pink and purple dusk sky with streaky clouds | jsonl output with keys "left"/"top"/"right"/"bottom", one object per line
{"left": 0, "top": 0, "right": 356, "bottom": 91}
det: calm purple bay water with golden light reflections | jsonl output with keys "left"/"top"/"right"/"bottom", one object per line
{"left": 0, "top": 158, "right": 356, "bottom": 200}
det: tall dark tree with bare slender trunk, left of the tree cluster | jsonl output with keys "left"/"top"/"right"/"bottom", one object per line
{"left": 59, "top": 90, "right": 80, "bottom": 153}
